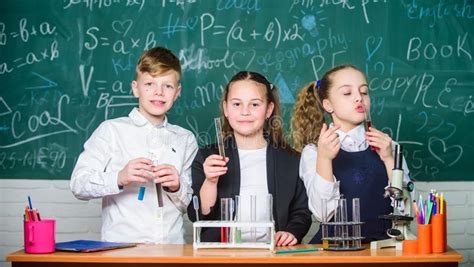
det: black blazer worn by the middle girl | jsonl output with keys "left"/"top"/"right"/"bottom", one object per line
{"left": 188, "top": 138, "right": 311, "bottom": 243}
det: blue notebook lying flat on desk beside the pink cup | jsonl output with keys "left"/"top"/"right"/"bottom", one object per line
{"left": 56, "top": 240, "right": 137, "bottom": 252}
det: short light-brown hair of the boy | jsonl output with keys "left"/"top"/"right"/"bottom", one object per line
{"left": 136, "top": 47, "right": 181, "bottom": 78}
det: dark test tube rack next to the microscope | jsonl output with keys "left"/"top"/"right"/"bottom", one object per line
{"left": 321, "top": 221, "right": 365, "bottom": 251}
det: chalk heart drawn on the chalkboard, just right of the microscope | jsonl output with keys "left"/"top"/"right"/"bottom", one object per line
{"left": 428, "top": 137, "right": 463, "bottom": 167}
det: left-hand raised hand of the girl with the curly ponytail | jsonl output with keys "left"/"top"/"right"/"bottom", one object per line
{"left": 318, "top": 123, "right": 341, "bottom": 160}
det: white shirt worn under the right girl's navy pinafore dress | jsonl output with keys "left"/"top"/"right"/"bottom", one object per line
{"left": 299, "top": 124, "right": 414, "bottom": 221}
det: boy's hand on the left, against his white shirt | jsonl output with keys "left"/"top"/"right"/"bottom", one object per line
{"left": 117, "top": 158, "right": 152, "bottom": 186}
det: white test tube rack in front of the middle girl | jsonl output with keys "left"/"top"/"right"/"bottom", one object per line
{"left": 193, "top": 221, "right": 275, "bottom": 250}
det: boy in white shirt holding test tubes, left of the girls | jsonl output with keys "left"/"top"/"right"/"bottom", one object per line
{"left": 70, "top": 47, "right": 197, "bottom": 244}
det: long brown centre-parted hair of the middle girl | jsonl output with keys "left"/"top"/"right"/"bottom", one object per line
{"left": 220, "top": 71, "right": 292, "bottom": 150}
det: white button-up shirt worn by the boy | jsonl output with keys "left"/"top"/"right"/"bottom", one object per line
{"left": 70, "top": 108, "right": 198, "bottom": 244}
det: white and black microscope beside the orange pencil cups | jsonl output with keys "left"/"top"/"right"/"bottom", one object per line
{"left": 370, "top": 145, "right": 416, "bottom": 250}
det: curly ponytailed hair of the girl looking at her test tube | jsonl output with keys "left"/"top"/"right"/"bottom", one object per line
{"left": 291, "top": 64, "right": 363, "bottom": 152}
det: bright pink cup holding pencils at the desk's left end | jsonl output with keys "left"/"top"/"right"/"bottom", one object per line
{"left": 23, "top": 220, "right": 56, "bottom": 254}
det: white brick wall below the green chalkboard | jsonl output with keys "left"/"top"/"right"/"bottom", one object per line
{"left": 0, "top": 180, "right": 474, "bottom": 267}
